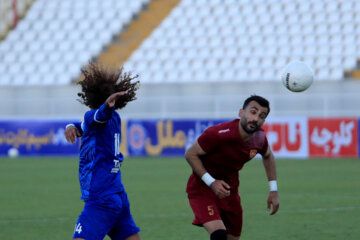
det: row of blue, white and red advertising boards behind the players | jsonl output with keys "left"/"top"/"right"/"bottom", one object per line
{"left": 0, "top": 117, "right": 360, "bottom": 159}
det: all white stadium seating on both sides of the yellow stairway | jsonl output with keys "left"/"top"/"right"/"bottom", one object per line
{"left": 0, "top": 0, "right": 360, "bottom": 86}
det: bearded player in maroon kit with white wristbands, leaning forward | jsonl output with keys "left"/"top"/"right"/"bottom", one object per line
{"left": 185, "top": 95, "right": 279, "bottom": 240}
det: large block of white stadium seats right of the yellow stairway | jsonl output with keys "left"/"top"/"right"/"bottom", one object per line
{"left": 126, "top": 0, "right": 360, "bottom": 82}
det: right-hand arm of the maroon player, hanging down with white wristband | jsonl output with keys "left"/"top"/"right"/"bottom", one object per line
{"left": 263, "top": 147, "right": 280, "bottom": 215}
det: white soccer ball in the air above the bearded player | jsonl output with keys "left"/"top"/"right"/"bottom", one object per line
{"left": 281, "top": 61, "right": 314, "bottom": 92}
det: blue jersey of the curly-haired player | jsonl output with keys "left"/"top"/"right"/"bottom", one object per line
{"left": 75, "top": 105, "right": 124, "bottom": 204}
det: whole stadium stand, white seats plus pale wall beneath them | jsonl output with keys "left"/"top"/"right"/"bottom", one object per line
{"left": 0, "top": 0, "right": 360, "bottom": 119}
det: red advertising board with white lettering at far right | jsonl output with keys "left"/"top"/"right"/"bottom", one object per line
{"left": 308, "top": 118, "right": 358, "bottom": 157}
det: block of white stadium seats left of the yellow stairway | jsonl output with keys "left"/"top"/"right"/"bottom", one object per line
{"left": 0, "top": 0, "right": 149, "bottom": 86}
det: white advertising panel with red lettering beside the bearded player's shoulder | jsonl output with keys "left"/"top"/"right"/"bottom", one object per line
{"left": 263, "top": 117, "right": 309, "bottom": 158}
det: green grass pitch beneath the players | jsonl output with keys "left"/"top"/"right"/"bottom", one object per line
{"left": 0, "top": 157, "right": 360, "bottom": 240}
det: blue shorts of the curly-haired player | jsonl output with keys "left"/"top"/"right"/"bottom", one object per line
{"left": 73, "top": 192, "right": 140, "bottom": 240}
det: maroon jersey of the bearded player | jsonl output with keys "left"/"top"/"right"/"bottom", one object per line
{"left": 187, "top": 119, "right": 268, "bottom": 193}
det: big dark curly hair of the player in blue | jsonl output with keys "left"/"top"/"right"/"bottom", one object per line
{"left": 77, "top": 62, "right": 140, "bottom": 109}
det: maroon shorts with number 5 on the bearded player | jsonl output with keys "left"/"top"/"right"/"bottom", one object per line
{"left": 186, "top": 175, "right": 243, "bottom": 236}
